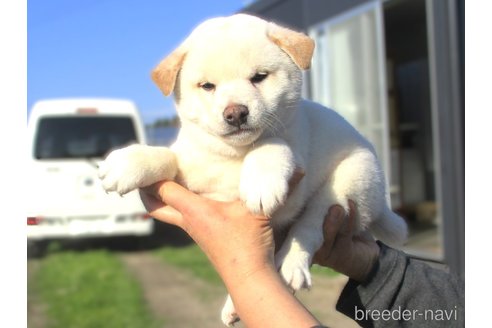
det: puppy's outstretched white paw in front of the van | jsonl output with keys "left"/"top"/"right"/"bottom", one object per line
{"left": 98, "top": 145, "right": 154, "bottom": 195}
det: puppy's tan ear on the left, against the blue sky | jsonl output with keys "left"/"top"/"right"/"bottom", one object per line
{"left": 151, "top": 45, "right": 186, "bottom": 96}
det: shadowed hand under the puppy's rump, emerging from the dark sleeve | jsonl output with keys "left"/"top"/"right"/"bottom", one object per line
{"left": 313, "top": 200, "right": 380, "bottom": 282}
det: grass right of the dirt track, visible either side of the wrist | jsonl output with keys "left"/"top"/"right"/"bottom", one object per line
{"left": 155, "top": 244, "right": 339, "bottom": 284}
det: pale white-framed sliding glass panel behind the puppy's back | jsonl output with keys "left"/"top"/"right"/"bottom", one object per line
{"left": 310, "top": 4, "right": 390, "bottom": 191}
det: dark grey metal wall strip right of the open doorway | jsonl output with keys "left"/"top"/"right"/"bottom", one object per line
{"left": 427, "top": 0, "right": 465, "bottom": 275}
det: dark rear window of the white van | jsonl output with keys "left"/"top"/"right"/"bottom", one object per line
{"left": 34, "top": 116, "right": 137, "bottom": 159}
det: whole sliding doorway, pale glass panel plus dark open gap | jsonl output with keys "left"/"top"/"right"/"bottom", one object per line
{"left": 309, "top": 0, "right": 444, "bottom": 261}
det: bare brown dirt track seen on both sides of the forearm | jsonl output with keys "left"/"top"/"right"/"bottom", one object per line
{"left": 121, "top": 252, "right": 358, "bottom": 328}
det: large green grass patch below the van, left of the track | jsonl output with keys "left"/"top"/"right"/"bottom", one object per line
{"left": 29, "top": 250, "right": 162, "bottom": 328}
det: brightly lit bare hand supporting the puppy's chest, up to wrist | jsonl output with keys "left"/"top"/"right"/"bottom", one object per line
{"left": 140, "top": 181, "right": 274, "bottom": 279}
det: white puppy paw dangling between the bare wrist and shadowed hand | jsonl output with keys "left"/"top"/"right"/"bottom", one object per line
{"left": 275, "top": 250, "right": 312, "bottom": 291}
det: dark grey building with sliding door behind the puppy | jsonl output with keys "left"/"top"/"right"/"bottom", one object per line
{"left": 242, "top": 0, "right": 465, "bottom": 275}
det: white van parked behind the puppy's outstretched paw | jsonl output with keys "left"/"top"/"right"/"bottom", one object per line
{"left": 26, "top": 99, "right": 154, "bottom": 242}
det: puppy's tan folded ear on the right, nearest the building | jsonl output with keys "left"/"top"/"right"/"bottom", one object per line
{"left": 268, "top": 23, "right": 314, "bottom": 69}
